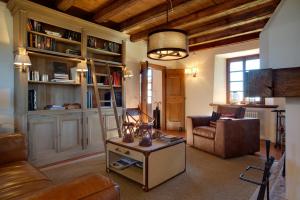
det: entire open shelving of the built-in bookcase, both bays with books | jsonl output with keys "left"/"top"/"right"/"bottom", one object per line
{"left": 26, "top": 18, "right": 124, "bottom": 112}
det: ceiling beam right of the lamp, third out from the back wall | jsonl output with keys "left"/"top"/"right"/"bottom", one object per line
{"left": 187, "top": 3, "right": 277, "bottom": 38}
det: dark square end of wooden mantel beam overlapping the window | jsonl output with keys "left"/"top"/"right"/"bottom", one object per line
{"left": 244, "top": 69, "right": 273, "bottom": 97}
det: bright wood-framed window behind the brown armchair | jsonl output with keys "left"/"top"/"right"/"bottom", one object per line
{"left": 227, "top": 55, "right": 263, "bottom": 103}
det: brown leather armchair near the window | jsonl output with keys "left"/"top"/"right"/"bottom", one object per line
{"left": 186, "top": 106, "right": 260, "bottom": 158}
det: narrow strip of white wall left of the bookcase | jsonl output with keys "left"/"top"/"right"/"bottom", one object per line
{"left": 0, "top": 2, "right": 14, "bottom": 133}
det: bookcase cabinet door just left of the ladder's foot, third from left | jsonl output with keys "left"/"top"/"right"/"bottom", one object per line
{"left": 87, "top": 113, "right": 104, "bottom": 152}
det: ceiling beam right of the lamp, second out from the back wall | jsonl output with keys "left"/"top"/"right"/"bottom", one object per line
{"left": 189, "top": 19, "right": 268, "bottom": 46}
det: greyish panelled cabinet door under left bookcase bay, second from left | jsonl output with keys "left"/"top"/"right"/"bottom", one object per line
{"left": 59, "top": 114, "right": 83, "bottom": 152}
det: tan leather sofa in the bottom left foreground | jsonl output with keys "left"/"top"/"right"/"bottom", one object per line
{"left": 0, "top": 134, "right": 120, "bottom": 200}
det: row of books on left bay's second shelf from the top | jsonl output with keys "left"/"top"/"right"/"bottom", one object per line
{"left": 28, "top": 33, "right": 56, "bottom": 51}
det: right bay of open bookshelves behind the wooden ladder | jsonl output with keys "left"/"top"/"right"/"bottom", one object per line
{"left": 87, "top": 36, "right": 123, "bottom": 109}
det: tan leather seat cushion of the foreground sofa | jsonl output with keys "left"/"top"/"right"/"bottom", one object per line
{"left": 0, "top": 161, "right": 51, "bottom": 199}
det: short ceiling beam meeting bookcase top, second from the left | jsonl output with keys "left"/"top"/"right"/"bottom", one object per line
{"left": 93, "top": 0, "right": 138, "bottom": 23}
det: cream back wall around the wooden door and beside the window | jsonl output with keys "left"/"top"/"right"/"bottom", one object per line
{"left": 126, "top": 40, "right": 259, "bottom": 116}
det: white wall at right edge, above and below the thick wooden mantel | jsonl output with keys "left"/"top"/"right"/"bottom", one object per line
{"left": 260, "top": 0, "right": 300, "bottom": 200}
